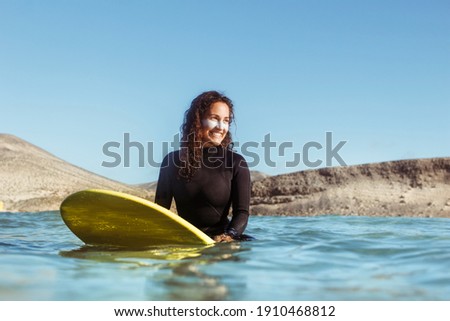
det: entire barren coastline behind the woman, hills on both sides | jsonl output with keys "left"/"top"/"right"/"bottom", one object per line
{"left": 0, "top": 134, "right": 450, "bottom": 217}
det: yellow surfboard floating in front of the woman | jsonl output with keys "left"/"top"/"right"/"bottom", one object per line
{"left": 60, "top": 189, "right": 214, "bottom": 248}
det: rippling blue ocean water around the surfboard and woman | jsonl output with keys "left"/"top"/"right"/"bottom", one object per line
{"left": 0, "top": 212, "right": 450, "bottom": 300}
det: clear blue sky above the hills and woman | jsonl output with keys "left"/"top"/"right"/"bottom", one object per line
{"left": 0, "top": 0, "right": 450, "bottom": 183}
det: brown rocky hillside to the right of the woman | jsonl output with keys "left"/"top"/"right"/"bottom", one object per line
{"left": 252, "top": 158, "right": 450, "bottom": 217}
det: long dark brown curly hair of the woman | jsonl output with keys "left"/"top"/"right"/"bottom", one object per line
{"left": 178, "top": 91, "right": 234, "bottom": 180}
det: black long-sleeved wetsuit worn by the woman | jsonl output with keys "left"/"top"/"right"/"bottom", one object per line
{"left": 155, "top": 147, "right": 250, "bottom": 237}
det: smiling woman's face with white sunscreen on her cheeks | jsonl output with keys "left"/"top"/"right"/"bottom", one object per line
{"left": 202, "top": 102, "right": 230, "bottom": 147}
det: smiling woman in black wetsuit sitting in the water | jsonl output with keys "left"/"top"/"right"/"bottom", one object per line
{"left": 155, "top": 91, "right": 250, "bottom": 242}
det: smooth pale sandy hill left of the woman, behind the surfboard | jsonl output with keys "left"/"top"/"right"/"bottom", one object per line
{"left": 0, "top": 134, "right": 150, "bottom": 211}
